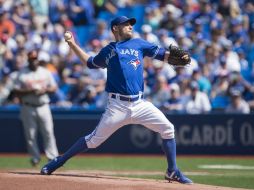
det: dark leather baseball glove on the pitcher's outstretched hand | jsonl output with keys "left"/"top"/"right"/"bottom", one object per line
{"left": 168, "top": 45, "right": 191, "bottom": 67}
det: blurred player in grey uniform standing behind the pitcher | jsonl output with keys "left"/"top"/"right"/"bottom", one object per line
{"left": 14, "top": 50, "right": 58, "bottom": 166}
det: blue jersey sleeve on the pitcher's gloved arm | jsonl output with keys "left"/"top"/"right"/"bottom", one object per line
{"left": 140, "top": 39, "right": 166, "bottom": 61}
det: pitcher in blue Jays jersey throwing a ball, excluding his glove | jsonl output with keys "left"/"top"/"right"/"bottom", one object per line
{"left": 41, "top": 16, "right": 192, "bottom": 184}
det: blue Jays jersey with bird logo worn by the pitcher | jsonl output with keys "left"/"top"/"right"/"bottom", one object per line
{"left": 87, "top": 38, "right": 166, "bottom": 95}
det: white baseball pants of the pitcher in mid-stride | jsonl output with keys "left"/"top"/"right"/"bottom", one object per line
{"left": 85, "top": 95, "right": 174, "bottom": 148}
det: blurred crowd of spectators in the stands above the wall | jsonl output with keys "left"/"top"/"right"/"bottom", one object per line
{"left": 0, "top": 0, "right": 254, "bottom": 114}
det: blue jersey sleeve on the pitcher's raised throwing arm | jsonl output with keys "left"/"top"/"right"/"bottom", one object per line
{"left": 87, "top": 46, "right": 110, "bottom": 69}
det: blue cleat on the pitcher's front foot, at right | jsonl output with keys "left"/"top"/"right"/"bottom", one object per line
{"left": 165, "top": 169, "right": 193, "bottom": 185}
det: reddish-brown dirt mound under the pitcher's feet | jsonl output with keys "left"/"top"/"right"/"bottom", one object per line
{"left": 0, "top": 170, "right": 247, "bottom": 190}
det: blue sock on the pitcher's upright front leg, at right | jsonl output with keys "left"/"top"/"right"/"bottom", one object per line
{"left": 162, "top": 138, "right": 177, "bottom": 172}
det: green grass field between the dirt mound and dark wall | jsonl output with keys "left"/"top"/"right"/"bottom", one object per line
{"left": 0, "top": 155, "right": 254, "bottom": 189}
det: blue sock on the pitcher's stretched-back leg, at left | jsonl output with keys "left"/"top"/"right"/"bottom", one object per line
{"left": 60, "top": 137, "right": 88, "bottom": 163}
